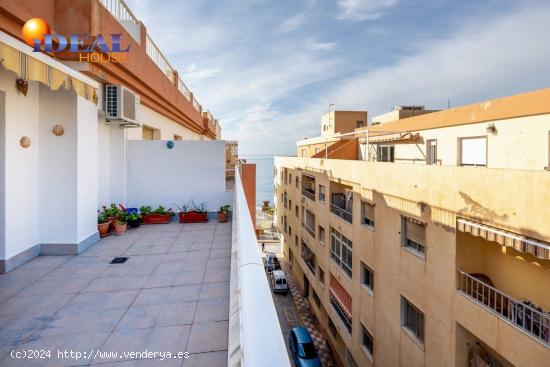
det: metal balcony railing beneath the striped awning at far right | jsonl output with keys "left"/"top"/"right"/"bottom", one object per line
{"left": 458, "top": 270, "right": 550, "bottom": 348}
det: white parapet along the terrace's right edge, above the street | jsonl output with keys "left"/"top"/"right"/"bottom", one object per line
{"left": 228, "top": 170, "right": 290, "bottom": 367}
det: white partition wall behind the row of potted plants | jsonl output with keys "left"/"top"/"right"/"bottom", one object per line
{"left": 127, "top": 140, "right": 231, "bottom": 211}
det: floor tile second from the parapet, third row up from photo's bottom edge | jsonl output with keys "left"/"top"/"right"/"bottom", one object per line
{"left": 117, "top": 302, "right": 197, "bottom": 330}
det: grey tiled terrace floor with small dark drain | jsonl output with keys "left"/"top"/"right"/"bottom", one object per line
{"left": 0, "top": 221, "right": 231, "bottom": 367}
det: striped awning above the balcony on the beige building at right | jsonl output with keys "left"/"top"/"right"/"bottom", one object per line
{"left": 457, "top": 218, "right": 550, "bottom": 260}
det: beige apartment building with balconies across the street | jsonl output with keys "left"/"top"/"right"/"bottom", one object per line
{"left": 275, "top": 89, "right": 550, "bottom": 367}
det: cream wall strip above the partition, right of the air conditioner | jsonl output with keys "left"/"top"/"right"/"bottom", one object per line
{"left": 128, "top": 104, "right": 203, "bottom": 140}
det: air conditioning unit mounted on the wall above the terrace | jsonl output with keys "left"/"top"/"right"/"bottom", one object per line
{"left": 105, "top": 84, "right": 139, "bottom": 126}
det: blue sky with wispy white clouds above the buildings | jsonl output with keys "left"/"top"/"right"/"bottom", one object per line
{"left": 127, "top": 0, "right": 550, "bottom": 155}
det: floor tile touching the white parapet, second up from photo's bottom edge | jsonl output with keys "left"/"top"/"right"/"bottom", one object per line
{"left": 187, "top": 321, "right": 228, "bottom": 354}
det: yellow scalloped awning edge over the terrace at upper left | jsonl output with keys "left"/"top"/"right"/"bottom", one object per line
{"left": 0, "top": 42, "right": 98, "bottom": 104}
